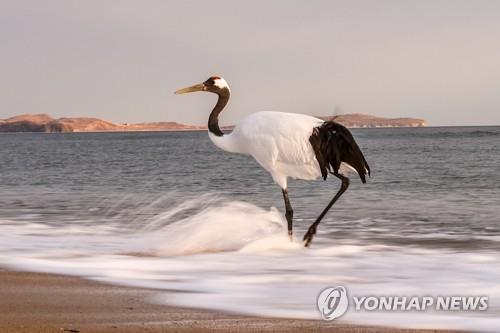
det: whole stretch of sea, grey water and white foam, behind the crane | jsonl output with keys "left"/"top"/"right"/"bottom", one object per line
{"left": 0, "top": 127, "right": 500, "bottom": 332}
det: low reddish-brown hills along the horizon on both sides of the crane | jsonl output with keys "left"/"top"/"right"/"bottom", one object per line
{"left": 0, "top": 113, "right": 426, "bottom": 133}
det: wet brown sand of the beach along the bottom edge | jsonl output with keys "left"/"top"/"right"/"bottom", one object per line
{"left": 0, "top": 271, "right": 460, "bottom": 333}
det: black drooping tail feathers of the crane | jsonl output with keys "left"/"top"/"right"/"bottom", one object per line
{"left": 309, "top": 121, "right": 370, "bottom": 183}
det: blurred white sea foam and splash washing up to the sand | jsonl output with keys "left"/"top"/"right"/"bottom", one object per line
{"left": 0, "top": 197, "right": 500, "bottom": 332}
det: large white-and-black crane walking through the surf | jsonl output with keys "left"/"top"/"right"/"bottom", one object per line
{"left": 175, "top": 76, "right": 370, "bottom": 247}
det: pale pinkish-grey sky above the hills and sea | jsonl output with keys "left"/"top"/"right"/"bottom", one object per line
{"left": 0, "top": 0, "right": 500, "bottom": 126}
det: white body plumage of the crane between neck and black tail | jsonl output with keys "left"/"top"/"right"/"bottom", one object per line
{"left": 209, "top": 111, "right": 323, "bottom": 189}
